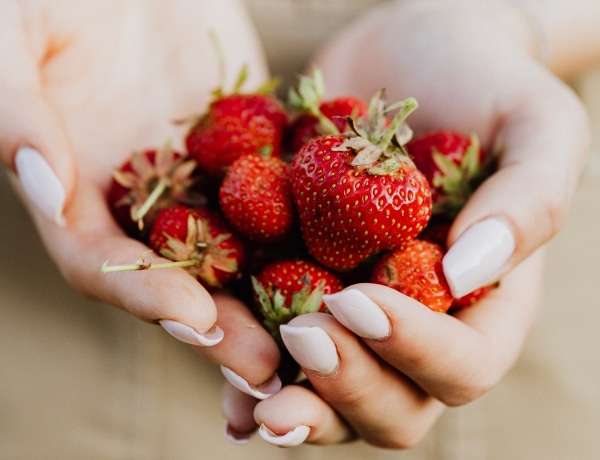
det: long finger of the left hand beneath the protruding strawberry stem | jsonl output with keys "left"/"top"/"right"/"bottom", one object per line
{"left": 33, "top": 184, "right": 223, "bottom": 346}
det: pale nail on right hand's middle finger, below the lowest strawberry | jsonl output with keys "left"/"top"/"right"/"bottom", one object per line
{"left": 279, "top": 324, "right": 339, "bottom": 375}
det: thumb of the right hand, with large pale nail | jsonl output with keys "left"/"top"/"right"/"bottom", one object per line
{"left": 444, "top": 70, "right": 589, "bottom": 297}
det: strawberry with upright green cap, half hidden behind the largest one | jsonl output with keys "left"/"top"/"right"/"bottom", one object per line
{"left": 287, "top": 69, "right": 369, "bottom": 152}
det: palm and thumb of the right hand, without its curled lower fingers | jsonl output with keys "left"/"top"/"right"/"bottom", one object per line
{"left": 318, "top": 0, "right": 590, "bottom": 296}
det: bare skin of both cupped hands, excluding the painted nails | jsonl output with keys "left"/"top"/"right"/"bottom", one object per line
{"left": 0, "top": 0, "right": 600, "bottom": 448}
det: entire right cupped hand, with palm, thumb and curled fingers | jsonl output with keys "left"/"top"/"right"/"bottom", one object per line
{"left": 224, "top": 1, "right": 589, "bottom": 448}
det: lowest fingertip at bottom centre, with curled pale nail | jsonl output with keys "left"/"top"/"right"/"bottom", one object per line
{"left": 254, "top": 385, "right": 356, "bottom": 447}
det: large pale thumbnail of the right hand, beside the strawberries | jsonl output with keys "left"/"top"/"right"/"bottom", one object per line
{"left": 443, "top": 218, "right": 515, "bottom": 298}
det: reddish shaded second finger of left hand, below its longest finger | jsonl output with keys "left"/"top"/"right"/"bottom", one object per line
{"left": 199, "top": 293, "right": 285, "bottom": 399}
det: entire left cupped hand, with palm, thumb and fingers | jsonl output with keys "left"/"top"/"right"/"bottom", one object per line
{"left": 0, "top": 0, "right": 279, "bottom": 374}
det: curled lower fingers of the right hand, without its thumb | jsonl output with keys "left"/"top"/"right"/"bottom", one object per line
{"left": 243, "top": 251, "right": 543, "bottom": 449}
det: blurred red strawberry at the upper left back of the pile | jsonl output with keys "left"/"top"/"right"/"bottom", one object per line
{"left": 185, "top": 68, "right": 288, "bottom": 178}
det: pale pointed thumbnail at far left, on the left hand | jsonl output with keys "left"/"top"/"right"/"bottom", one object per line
{"left": 15, "top": 147, "right": 66, "bottom": 226}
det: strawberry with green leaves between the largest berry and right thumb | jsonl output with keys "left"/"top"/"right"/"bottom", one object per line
{"left": 406, "top": 130, "right": 493, "bottom": 219}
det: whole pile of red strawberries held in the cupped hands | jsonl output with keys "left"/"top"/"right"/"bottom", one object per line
{"left": 108, "top": 71, "right": 493, "bottom": 342}
